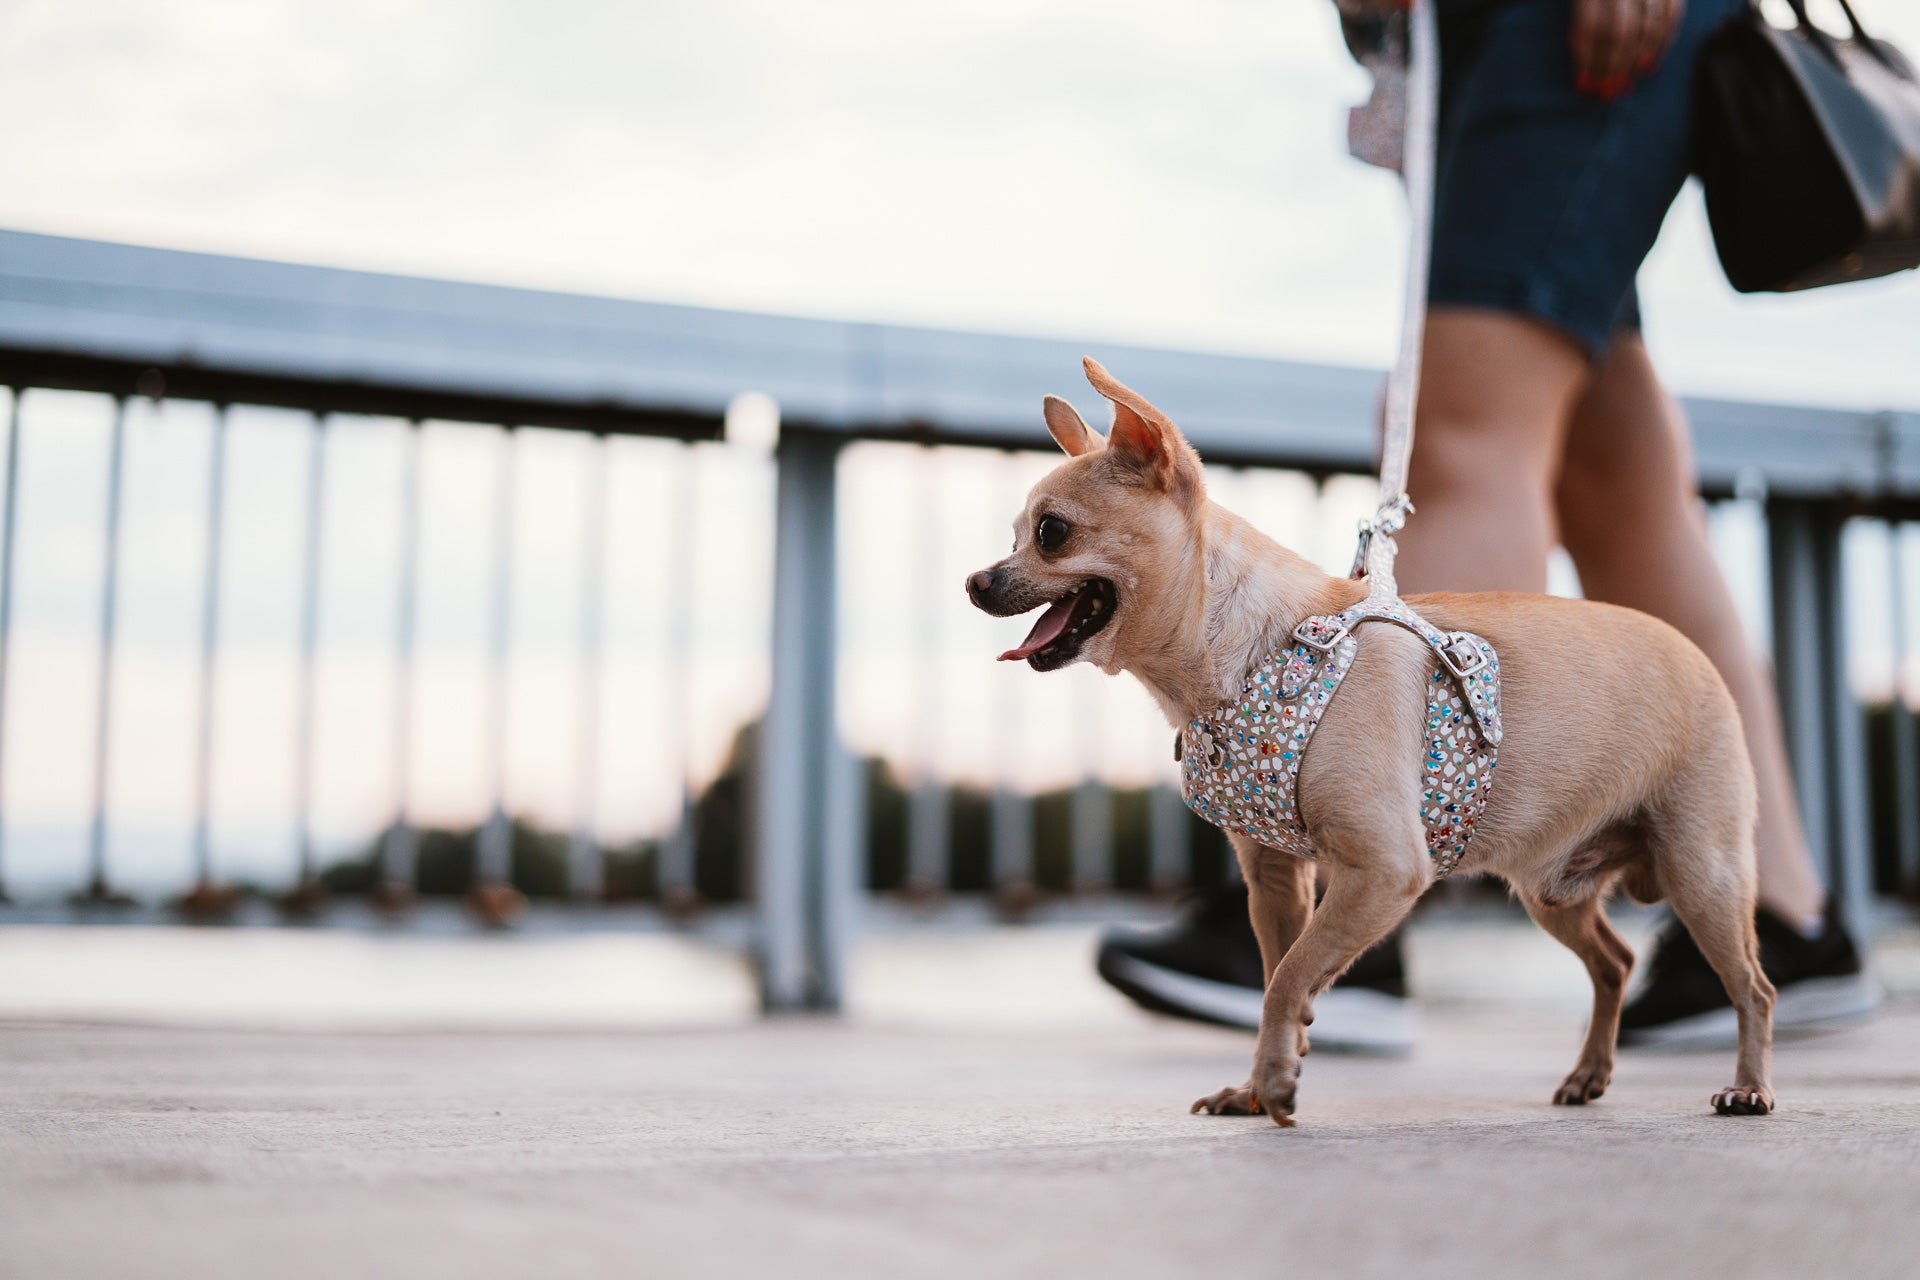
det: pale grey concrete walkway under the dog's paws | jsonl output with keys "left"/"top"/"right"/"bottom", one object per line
{"left": 0, "top": 1002, "right": 1920, "bottom": 1280}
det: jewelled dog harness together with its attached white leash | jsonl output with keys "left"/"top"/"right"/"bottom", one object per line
{"left": 1173, "top": 0, "right": 1500, "bottom": 875}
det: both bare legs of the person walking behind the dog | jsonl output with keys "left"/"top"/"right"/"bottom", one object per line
{"left": 1398, "top": 307, "right": 1824, "bottom": 927}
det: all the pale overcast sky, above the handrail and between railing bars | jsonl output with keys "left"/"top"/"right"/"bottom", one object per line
{"left": 0, "top": 0, "right": 1920, "bottom": 898}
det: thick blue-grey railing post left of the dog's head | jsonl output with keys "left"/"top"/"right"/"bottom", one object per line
{"left": 755, "top": 432, "right": 856, "bottom": 1011}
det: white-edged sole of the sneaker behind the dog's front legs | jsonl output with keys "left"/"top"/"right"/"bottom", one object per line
{"left": 1100, "top": 952, "right": 1419, "bottom": 1055}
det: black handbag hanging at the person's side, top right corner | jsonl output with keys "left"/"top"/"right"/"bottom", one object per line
{"left": 1693, "top": 0, "right": 1920, "bottom": 294}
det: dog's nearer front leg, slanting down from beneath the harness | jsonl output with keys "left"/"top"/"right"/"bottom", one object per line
{"left": 1248, "top": 848, "right": 1432, "bottom": 1125}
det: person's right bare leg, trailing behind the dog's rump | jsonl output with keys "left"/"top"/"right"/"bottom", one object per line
{"left": 1551, "top": 334, "right": 1826, "bottom": 927}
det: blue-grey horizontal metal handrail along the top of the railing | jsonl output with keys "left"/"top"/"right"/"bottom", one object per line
{"left": 0, "top": 230, "right": 1920, "bottom": 505}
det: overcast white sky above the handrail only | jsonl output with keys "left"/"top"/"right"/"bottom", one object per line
{"left": 11, "top": 0, "right": 1920, "bottom": 407}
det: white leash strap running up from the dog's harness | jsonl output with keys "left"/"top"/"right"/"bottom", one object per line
{"left": 1352, "top": 0, "right": 1440, "bottom": 599}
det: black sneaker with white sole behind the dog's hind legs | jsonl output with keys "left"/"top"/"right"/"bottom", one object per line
{"left": 1620, "top": 900, "right": 1880, "bottom": 1048}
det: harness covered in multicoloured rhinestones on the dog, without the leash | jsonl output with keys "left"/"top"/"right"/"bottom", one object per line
{"left": 1173, "top": 595, "right": 1500, "bottom": 877}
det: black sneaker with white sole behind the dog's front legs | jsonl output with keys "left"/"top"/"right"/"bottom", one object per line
{"left": 1096, "top": 885, "right": 1419, "bottom": 1054}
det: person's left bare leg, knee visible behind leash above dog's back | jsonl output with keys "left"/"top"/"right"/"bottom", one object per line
{"left": 1396, "top": 305, "right": 1590, "bottom": 595}
